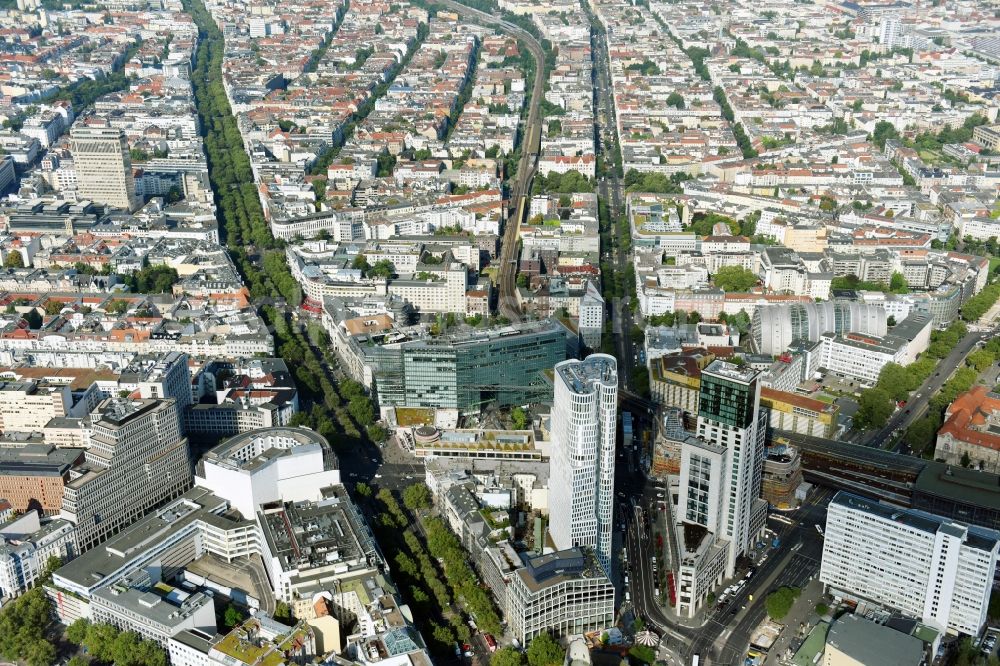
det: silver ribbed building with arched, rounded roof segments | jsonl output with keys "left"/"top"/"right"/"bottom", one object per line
{"left": 751, "top": 301, "right": 888, "bottom": 355}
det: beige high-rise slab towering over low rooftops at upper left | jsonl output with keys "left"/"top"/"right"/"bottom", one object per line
{"left": 70, "top": 127, "right": 141, "bottom": 211}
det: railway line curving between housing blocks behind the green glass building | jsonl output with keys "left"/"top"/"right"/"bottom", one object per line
{"left": 430, "top": 0, "right": 545, "bottom": 322}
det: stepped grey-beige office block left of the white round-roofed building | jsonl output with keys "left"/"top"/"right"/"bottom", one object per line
{"left": 62, "top": 398, "right": 191, "bottom": 551}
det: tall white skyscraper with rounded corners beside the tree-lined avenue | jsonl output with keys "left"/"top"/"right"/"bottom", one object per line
{"left": 549, "top": 354, "right": 618, "bottom": 573}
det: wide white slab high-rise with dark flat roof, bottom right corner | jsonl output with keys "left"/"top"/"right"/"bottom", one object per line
{"left": 820, "top": 492, "right": 1000, "bottom": 635}
